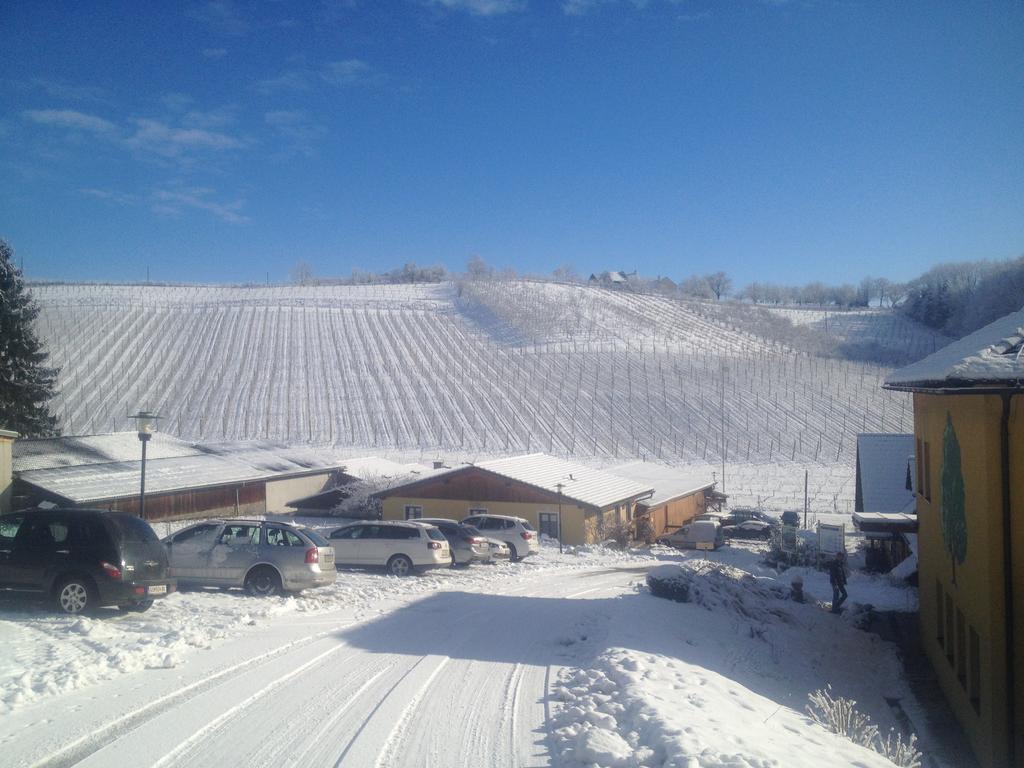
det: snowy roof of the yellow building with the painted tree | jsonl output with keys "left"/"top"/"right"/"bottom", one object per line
{"left": 885, "top": 309, "right": 1024, "bottom": 389}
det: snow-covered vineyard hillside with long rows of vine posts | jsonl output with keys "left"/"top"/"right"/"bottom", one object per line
{"left": 34, "top": 281, "right": 934, "bottom": 507}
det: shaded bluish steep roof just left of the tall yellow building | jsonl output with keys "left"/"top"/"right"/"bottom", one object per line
{"left": 857, "top": 433, "right": 914, "bottom": 512}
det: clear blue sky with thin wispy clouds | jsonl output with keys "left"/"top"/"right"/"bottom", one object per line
{"left": 0, "top": 0, "right": 1024, "bottom": 285}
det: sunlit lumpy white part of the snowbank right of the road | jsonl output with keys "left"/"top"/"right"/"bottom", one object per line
{"left": 553, "top": 648, "right": 892, "bottom": 768}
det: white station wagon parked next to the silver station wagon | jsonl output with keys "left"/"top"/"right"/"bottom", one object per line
{"left": 329, "top": 520, "right": 452, "bottom": 577}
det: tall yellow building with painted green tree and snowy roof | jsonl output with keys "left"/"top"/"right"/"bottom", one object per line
{"left": 886, "top": 310, "right": 1024, "bottom": 768}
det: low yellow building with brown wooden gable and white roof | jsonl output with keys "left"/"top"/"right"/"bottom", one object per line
{"left": 375, "top": 454, "right": 652, "bottom": 545}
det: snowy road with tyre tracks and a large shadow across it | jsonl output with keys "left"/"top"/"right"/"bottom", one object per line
{"left": 0, "top": 566, "right": 646, "bottom": 767}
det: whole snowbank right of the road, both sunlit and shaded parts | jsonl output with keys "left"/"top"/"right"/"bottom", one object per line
{"left": 551, "top": 548, "right": 910, "bottom": 768}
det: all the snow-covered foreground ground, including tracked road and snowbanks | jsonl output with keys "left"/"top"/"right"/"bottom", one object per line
{"left": 0, "top": 544, "right": 927, "bottom": 768}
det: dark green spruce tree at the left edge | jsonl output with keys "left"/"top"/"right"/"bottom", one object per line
{"left": 0, "top": 240, "right": 58, "bottom": 437}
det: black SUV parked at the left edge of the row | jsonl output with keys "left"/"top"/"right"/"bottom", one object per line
{"left": 0, "top": 509, "right": 177, "bottom": 613}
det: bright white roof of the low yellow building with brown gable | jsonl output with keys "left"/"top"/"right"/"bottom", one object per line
{"left": 476, "top": 454, "right": 652, "bottom": 508}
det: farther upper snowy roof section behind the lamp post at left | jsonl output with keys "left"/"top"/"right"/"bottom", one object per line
{"left": 12, "top": 432, "right": 202, "bottom": 472}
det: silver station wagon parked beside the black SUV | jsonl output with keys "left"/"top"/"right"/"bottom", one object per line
{"left": 164, "top": 519, "right": 338, "bottom": 596}
